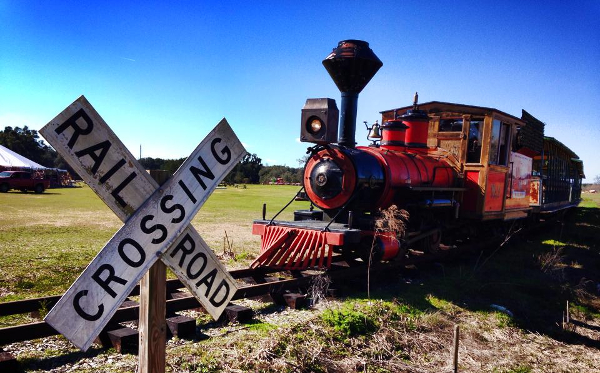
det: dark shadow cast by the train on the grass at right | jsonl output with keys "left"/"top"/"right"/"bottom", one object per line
{"left": 342, "top": 208, "right": 600, "bottom": 349}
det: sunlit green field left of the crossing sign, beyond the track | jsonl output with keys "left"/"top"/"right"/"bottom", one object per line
{"left": 0, "top": 187, "right": 121, "bottom": 301}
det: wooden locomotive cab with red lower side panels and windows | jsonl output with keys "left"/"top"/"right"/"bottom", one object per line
{"left": 381, "top": 101, "right": 541, "bottom": 220}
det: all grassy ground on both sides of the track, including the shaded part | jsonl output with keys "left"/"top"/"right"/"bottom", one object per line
{"left": 0, "top": 186, "right": 600, "bottom": 373}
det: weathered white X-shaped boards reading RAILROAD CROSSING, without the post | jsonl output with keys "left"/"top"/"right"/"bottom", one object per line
{"left": 40, "top": 96, "right": 246, "bottom": 350}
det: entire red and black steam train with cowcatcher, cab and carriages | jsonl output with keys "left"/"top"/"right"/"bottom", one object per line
{"left": 252, "top": 40, "right": 585, "bottom": 270}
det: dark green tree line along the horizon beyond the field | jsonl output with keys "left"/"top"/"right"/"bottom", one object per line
{"left": 0, "top": 126, "right": 303, "bottom": 184}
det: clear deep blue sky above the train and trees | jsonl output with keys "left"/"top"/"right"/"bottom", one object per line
{"left": 0, "top": 0, "right": 600, "bottom": 180}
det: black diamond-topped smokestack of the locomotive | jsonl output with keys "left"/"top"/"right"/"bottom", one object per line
{"left": 323, "top": 40, "right": 383, "bottom": 148}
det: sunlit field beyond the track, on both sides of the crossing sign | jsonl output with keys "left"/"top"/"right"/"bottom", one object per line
{"left": 0, "top": 185, "right": 308, "bottom": 302}
